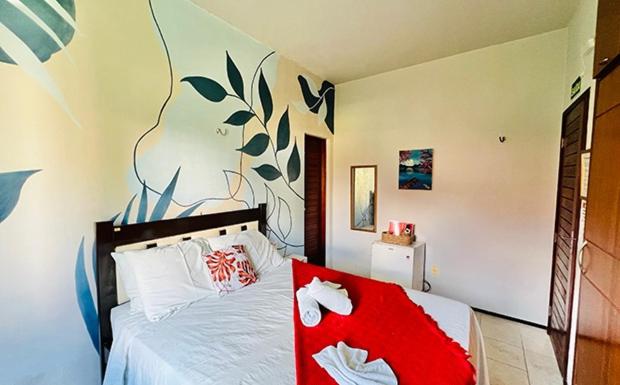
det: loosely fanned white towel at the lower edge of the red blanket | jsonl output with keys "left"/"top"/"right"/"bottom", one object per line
{"left": 312, "top": 341, "right": 398, "bottom": 385}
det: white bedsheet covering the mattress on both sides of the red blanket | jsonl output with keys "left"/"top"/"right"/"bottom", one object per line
{"left": 104, "top": 262, "right": 486, "bottom": 385}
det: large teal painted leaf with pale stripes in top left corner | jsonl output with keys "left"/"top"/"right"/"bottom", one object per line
{"left": 0, "top": 0, "right": 75, "bottom": 64}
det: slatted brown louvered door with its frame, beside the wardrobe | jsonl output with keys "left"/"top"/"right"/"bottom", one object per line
{"left": 547, "top": 90, "right": 590, "bottom": 378}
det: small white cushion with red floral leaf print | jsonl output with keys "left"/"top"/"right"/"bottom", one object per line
{"left": 202, "top": 245, "right": 256, "bottom": 294}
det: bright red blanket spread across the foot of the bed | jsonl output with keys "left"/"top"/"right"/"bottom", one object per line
{"left": 293, "top": 260, "right": 476, "bottom": 385}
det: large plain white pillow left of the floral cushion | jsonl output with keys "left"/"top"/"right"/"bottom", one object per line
{"left": 127, "top": 244, "right": 209, "bottom": 321}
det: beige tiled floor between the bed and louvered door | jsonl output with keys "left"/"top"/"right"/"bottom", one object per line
{"left": 476, "top": 313, "right": 562, "bottom": 385}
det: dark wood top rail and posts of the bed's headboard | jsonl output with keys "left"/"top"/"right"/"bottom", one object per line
{"left": 96, "top": 204, "right": 267, "bottom": 380}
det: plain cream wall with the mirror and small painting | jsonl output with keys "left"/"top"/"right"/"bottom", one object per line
{"left": 329, "top": 30, "right": 567, "bottom": 324}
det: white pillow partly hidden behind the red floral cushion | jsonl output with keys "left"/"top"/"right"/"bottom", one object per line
{"left": 208, "top": 230, "right": 284, "bottom": 277}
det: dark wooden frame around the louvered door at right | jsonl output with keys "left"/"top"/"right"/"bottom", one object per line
{"left": 547, "top": 88, "right": 590, "bottom": 376}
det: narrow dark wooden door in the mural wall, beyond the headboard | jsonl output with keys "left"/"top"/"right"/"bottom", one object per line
{"left": 304, "top": 135, "right": 327, "bottom": 266}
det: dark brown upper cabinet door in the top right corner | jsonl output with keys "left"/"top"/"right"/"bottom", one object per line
{"left": 594, "top": 0, "right": 620, "bottom": 76}
